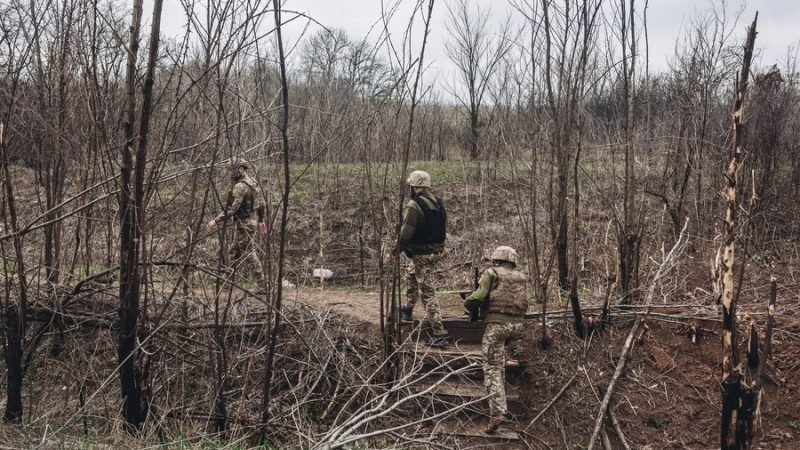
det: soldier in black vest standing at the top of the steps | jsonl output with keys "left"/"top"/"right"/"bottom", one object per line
{"left": 394, "top": 170, "right": 450, "bottom": 347}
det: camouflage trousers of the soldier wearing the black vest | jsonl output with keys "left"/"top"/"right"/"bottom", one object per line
{"left": 406, "top": 253, "right": 447, "bottom": 336}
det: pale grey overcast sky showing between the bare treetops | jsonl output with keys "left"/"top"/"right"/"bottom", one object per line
{"left": 155, "top": 0, "right": 800, "bottom": 91}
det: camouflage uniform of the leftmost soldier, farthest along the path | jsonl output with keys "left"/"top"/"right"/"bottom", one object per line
{"left": 216, "top": 175, "right": 265, "bottom": 279}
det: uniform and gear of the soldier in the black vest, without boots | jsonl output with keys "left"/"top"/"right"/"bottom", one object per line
{"left": 395, "top": 171, "right": 447, "bottom": 337}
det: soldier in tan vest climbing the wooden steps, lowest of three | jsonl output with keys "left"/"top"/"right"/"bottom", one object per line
{"left": 464, "top": 245, "right": 528, "bottom": 433}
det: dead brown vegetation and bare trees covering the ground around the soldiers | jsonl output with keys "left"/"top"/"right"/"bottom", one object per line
{"left": 0, "top": 0, "right": 800, "bottom": 449}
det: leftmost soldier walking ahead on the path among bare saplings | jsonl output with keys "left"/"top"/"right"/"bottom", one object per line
{"left": 208, "top": 159, "right": 267, "bottom": 280}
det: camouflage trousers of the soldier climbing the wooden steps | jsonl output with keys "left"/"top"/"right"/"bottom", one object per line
{"left": 482, "top": 322, "right": 522, "bottom": 417}
